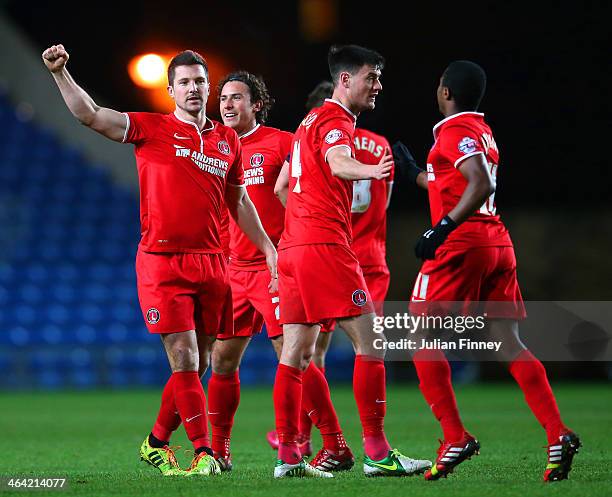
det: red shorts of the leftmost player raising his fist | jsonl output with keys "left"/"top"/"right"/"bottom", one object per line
{"left": 136, "top": 250, "right": 233, "bottom": 335}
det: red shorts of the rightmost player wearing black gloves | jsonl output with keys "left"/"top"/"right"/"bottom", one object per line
{"left": 410, "top": 247, "right": 527, "bottom": 319}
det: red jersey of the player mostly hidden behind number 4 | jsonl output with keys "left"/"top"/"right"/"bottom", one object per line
{"left": 352, "top": 128, "right": 395, "bottom": 267}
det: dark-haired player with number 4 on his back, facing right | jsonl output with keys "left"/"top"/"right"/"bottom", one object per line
{"left": 273, "top": 45, "right": 431, "bottom": 478}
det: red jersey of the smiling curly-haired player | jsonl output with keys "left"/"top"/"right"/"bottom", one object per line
{"left": 230, "top": 124, "right": 293, "bottom": 271}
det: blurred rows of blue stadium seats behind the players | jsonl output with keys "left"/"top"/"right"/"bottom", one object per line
{"left": 0, "top": 91, "right": 310, "bottom": 389}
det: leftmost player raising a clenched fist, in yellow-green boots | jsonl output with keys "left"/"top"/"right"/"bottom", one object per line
{"left": 42, "top": 45, "right": 277, "bottom": 476}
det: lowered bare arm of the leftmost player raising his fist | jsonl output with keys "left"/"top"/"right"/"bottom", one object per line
{"left": 225, "top": 185, "right": 278, "bottom": 293}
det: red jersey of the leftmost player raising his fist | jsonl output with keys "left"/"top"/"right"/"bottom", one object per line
{"left": 123, "top": 112, "right": 244, "bottom": 253}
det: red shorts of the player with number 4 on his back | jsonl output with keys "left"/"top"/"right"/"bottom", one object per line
{"left": 278, "top": 243, "right": 374, "bottom": 324}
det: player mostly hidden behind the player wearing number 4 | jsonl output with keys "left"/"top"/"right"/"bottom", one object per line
{"left": 268, "top": 81, "right": 395, "bottom": 454}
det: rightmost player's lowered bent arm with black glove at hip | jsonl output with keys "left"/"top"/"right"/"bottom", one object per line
{"left": 414, "top": 153, "right": 495, "bottom": 259}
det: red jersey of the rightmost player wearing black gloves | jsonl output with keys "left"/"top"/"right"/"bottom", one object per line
{"left": 427, "top": 112, "right": 512, "bottom": 246}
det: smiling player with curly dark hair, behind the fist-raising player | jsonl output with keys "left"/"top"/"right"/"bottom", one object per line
{"left": 208, "top": 71, "right": 354, "bottom": 473}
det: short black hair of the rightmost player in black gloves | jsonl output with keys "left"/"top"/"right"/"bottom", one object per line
{"left": 442, "top": 60, "right": 487, "bottom": 110}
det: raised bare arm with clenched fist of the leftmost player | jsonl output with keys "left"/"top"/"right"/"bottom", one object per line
{"left": 42, "top": 45, "right": 127, "bottom": 142}
